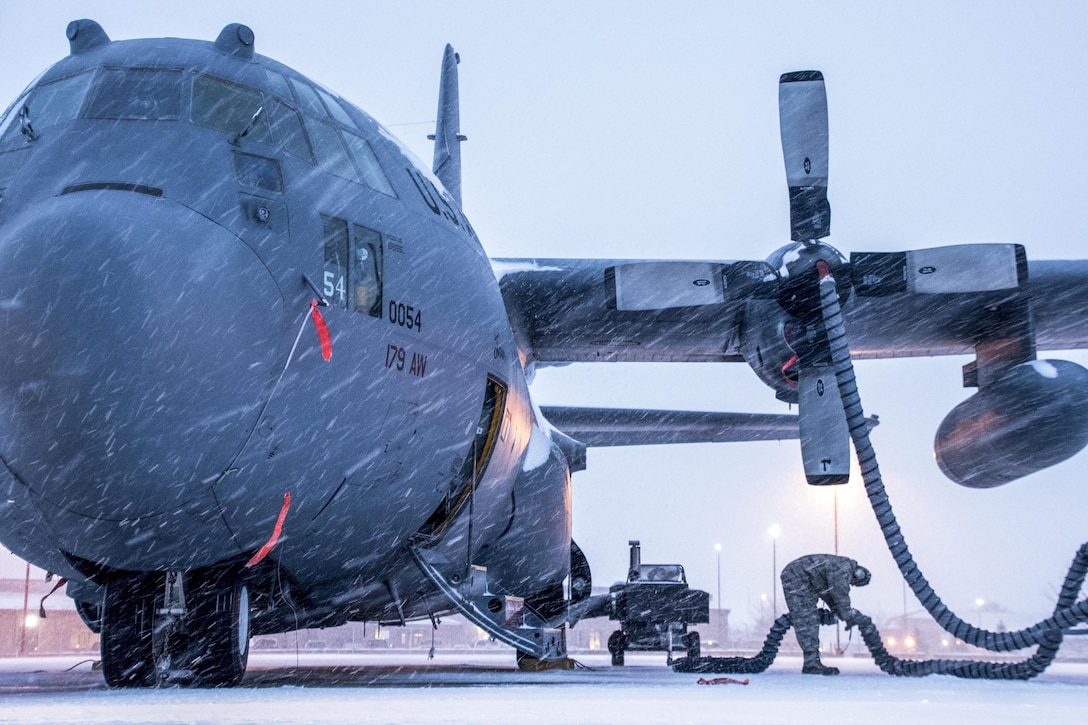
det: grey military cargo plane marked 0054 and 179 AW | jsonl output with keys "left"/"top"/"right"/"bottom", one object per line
{"left": 0, "top": 20, "right": 1088, "bottom": 687}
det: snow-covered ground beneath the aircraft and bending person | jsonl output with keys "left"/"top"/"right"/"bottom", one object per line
{"left": 0, "top": 653, "right": 1088, "bottom": 725}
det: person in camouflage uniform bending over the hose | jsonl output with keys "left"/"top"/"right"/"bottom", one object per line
{"left": 782, "top": 554, "right": 869, "bottom": 675}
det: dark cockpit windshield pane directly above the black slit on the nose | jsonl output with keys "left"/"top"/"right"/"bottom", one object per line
{"left": 85, "top": 67, "right": 184, "bottom": 121}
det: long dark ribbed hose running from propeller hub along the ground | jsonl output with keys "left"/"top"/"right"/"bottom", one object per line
{"left": 673, "top": 261, "right": 1088, "bottom": 679}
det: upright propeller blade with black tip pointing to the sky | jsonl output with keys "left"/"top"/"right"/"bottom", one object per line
{"left": 778, "top": 71, "right": 831, "bottom": 242}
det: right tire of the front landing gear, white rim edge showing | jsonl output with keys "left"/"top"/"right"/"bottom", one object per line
{"left": 186, "top": 572, "right": 249, "bottom": 687}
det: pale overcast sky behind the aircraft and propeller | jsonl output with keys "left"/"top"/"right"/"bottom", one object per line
{"left": 0, "top": 0, "right": 1088, "bottom": 627}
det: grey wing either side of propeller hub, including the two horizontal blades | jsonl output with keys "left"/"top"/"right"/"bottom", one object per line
{"left": 493, "top": 255, "right": 1088, "bottom": 372}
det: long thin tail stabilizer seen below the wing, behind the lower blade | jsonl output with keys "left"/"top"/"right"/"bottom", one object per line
{"left": 541, "top": 407, "right": 800, "bottom": 447}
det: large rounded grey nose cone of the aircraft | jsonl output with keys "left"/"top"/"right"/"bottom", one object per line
{"left": 0, "top": 191, "right": 283, "bottom": 520}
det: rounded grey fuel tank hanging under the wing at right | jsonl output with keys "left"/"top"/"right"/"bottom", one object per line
{"left": 934, "top": 360, "right": 1088, "bottom": 489}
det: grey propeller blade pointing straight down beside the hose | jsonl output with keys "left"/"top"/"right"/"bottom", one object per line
{"left": 798, "top": 365, "right": 850, "bottom": 486}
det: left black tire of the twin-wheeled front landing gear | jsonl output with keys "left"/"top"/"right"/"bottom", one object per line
{"left": 101, "top": 574, "right": 158, "bottom": 687}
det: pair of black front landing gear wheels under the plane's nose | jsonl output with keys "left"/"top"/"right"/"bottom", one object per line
{"left": 101, "top": 569, "right": 249, "bottom": 687}
